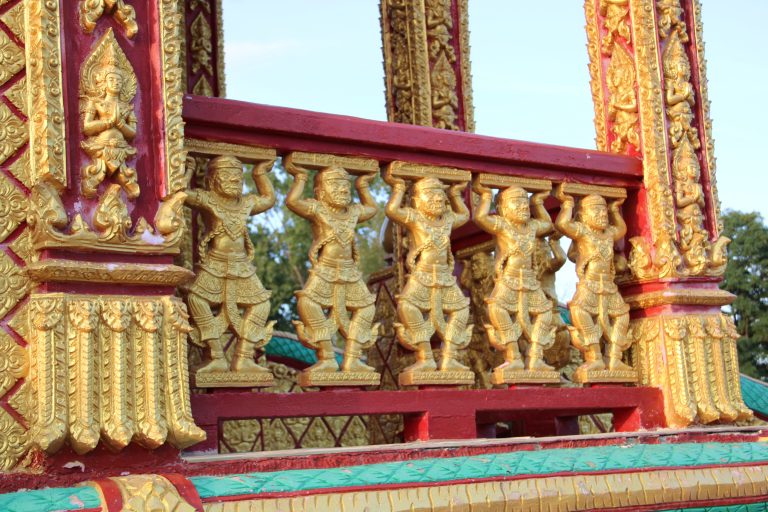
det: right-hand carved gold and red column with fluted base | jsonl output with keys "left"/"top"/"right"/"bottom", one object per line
{"left": 584, "top": 0, "right": 751, "bottom": 427}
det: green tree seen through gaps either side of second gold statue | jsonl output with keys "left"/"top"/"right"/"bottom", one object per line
{"left": 246, "top": 161, "right": 386, "bottom": 332}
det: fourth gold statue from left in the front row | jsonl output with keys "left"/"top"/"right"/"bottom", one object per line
{"left": 474, "top": 176, "right": 560, "bottom": 384}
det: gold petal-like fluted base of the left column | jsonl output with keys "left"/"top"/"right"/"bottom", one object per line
{"left": 29, "top": 294, "right": 205, "bottom": 453}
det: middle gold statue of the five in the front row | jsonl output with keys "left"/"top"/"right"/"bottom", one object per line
{"left": 385, "top": 164, "right": 475, "bottom": 385}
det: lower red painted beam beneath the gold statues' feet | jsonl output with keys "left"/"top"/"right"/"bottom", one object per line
{"left": 192, "top": 386, "right": 664, "bottom": 447}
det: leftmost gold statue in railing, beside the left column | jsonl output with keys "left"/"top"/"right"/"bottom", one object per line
{"left": 185, "top": 156, "right": 275, "bottom": 387}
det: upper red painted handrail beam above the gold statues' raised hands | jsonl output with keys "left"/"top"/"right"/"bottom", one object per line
{"left": 183, "top": 96, "right": 643, "bottom": 187}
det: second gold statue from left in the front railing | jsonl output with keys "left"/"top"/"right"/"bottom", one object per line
{"left": 285, "top": 155, "right": 380, "bottom": 386}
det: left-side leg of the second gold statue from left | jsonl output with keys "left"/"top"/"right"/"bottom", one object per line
{"left": 294, "top": 295, "right": 339, "bottom": 372}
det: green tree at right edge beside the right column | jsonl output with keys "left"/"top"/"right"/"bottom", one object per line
{"left": 721, "top": 210, "right": 768, "bottom": 380}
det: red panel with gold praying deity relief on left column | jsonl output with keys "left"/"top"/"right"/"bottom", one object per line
{"left": 27, "top": 0, "right": 184, "bottom": 254}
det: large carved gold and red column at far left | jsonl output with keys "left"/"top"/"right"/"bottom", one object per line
{"left": 7, "top": 0, "right": 204, "bottom": 462}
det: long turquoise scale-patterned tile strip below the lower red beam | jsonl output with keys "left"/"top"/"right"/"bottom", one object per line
{"left": 190, "top": 443, "right": 768, "bottom": 498}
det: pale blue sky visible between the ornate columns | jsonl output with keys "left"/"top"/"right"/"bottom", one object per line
{"left": 224, "top": 0, "right": 768, "bottom": 299}
